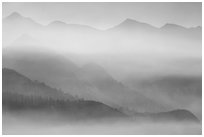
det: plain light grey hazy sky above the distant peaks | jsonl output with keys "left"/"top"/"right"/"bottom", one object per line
{"left": 3, "top": 2, "right": 202, "bottom": 29}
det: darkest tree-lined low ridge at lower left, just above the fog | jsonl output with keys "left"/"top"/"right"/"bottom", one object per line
{"left": 2, "top": 92, "right": 127, "bottom": 121}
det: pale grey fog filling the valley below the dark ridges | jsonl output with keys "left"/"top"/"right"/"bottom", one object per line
{"left": 3, "top": 114, "right": 202, "bottom": 135}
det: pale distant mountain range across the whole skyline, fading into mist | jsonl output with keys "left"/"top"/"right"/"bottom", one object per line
{"left": 3, "top": 12, "right": 202, "bottom": 45}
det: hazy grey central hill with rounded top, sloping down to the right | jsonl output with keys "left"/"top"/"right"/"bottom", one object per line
{"left": 78, "top": 63, "right": 170, "bottom": 112}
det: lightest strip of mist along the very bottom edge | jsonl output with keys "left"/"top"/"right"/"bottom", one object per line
{"left": 3, "top": 116, "right": 201, "bottom": 135}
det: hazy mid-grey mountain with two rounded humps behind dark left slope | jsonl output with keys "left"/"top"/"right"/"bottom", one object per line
{"left": 3, "top": 50, "right": 170, "bottom": 112}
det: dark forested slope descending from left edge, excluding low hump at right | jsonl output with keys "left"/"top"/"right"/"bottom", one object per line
{"left": 2, "top": 68, "right": 126, "bottom": 119}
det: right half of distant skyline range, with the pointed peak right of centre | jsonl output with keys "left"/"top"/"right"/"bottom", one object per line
{"left": 110, "top": 19, "right": 202, "bottom": 40}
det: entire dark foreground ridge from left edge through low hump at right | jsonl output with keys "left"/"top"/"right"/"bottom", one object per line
{"left": 2, "top": 68, "right": 199, "bottom": 122}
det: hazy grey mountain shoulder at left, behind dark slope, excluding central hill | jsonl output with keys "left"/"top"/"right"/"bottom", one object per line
{"left": 3, "top": 51, "right": 115, "bottom": 101}
